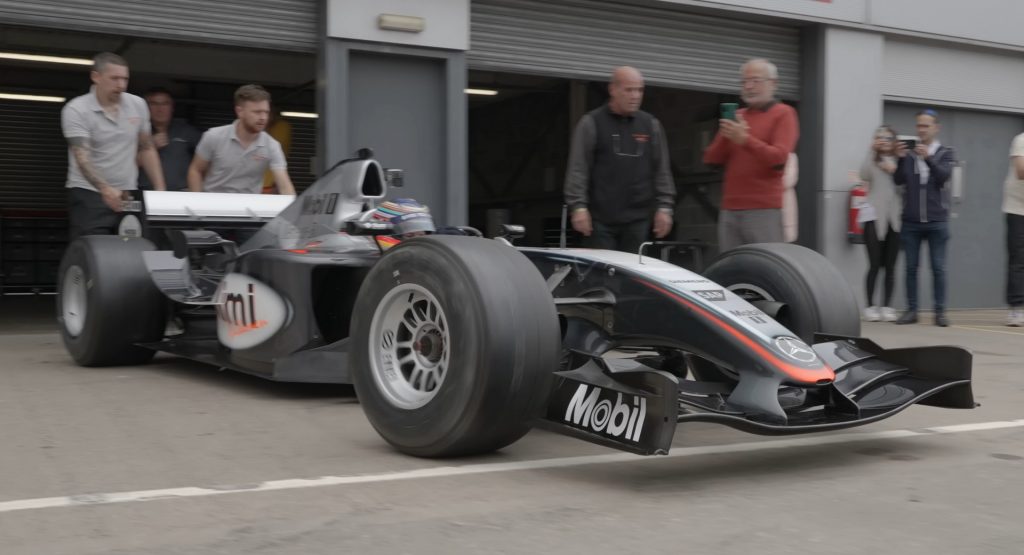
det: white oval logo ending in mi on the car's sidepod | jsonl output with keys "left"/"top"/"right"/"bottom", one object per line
{"left": 214, "top": 273, "right": 289, "bottom": 349}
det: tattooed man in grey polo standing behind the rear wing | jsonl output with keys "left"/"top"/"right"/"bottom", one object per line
{"left": 60, "top": 52, "right": 166, "bottom": 240}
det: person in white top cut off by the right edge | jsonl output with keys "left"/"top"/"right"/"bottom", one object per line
{"left": 1002, "top": 133, "right": 1024, "bottom": 327}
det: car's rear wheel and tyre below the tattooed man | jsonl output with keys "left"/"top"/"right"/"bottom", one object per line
{"left": 56, "top": 236, "right": 166, "bottom": 367}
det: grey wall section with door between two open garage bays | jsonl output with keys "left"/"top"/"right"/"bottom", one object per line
{"left": 317, "top": 0, "right": 469, "bottom": 224}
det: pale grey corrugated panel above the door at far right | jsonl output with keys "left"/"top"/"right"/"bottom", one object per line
{"left": 882, "top": 38, "right": 1024, "bottom": 113}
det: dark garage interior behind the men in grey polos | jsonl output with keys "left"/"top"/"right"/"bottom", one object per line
{"left": 0, "top": 28, "right": 316, "bottom": 295}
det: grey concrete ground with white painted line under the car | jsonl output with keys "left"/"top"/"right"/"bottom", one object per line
{"left": 0, "top": 298, "right": 1024, "bottom": 555}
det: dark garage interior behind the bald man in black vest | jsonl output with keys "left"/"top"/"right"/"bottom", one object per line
{"left": 469, "top": 71, "right": 757, "bottom": 261}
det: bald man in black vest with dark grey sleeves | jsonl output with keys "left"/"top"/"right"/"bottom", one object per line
{"left": 565, "top": 67, "right": 676, "bottom": 253}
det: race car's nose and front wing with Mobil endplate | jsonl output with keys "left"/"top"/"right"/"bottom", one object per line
{"left": 524, "top": 249, "right": 975, "bottom": 455}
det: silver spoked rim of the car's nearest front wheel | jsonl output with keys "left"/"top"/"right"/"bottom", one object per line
{"left": 370, "top": 284, "right": 452, "bottom": 410}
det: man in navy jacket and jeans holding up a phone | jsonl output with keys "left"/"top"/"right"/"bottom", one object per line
{"left": 893, "top": 110, "right": 955, "bottom": 328}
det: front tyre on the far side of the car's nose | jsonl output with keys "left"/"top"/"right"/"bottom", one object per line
{"left": 703, "top": 243, "right": 860, "bottom": 344}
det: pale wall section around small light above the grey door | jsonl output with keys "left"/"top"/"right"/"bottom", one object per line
{"left": 327, "top": 0, "right": 469, "bottom": 50}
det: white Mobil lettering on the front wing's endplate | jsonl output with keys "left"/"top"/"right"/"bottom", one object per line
{"left": 564, "top": 384, "right": 647, "bottom": 441}
